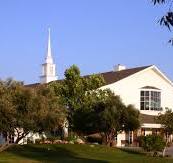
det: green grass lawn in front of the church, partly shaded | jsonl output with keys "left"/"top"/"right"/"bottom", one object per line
{"left": 0, "top": 144, "right": 173, "bottom": 163}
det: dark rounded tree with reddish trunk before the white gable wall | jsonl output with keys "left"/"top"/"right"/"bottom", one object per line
{"left": 73, "top": 90, "right": 140, "bottom": 146}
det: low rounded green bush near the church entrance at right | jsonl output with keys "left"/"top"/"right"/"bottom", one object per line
{"left": 139, "top": 135, "right": 165, "bottom": 155}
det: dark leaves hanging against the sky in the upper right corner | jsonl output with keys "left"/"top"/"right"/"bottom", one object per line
{"left": 152, "top": 0, "right": 173, "bottom": 45}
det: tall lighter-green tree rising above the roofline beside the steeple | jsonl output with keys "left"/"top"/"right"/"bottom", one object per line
{"left": 49, "top": 65, "right": 104, "bottom": 127}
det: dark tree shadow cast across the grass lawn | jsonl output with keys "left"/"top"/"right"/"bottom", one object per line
{"left": 6, "top": 145, "right": 107, "bottom": 163}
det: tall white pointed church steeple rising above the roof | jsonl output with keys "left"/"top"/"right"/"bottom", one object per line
{"left": 40, "top": 28, "right": 57, "bottom": 83}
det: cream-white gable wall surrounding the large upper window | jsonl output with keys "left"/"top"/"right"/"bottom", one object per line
{"left": 101, "top": 68, "right": 173, "bottom": 115}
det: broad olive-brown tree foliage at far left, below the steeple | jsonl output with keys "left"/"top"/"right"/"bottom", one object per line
{"left": 0, "top": 79, "right": 65, "bottom": 144}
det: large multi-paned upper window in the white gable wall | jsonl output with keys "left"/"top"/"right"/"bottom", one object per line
{"left": 140, "top": 90, "right": 162, "bottom": 111}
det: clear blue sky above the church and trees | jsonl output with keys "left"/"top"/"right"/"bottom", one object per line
{"left": 0, "top": 0, "right": 173, "bottom": 83}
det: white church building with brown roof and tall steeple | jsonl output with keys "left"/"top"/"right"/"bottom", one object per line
{"left": 29, "top": 29, "right": 173, "bottom": 146}
